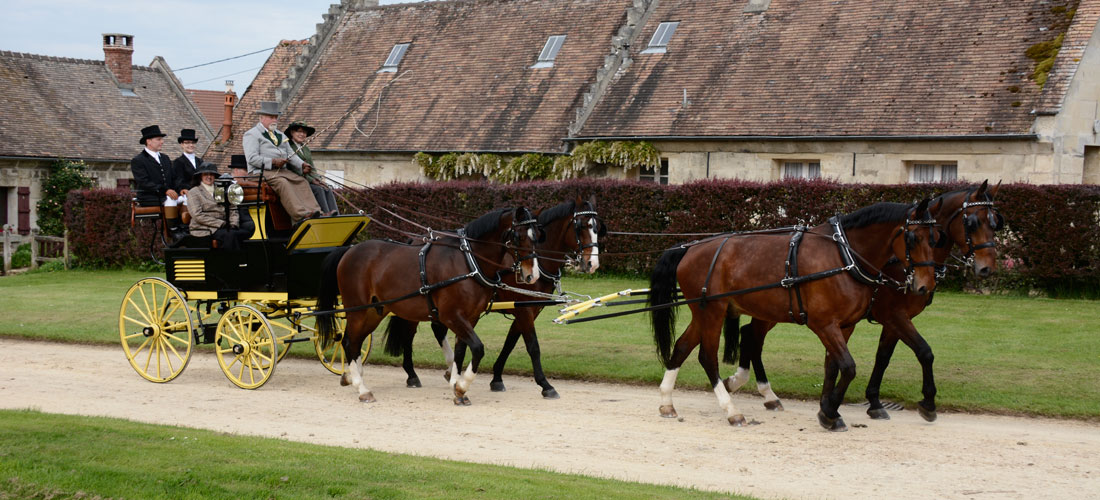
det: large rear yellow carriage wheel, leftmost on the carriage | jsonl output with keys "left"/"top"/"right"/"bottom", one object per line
{"left": 119, "top": 278, "right": 194, "bottom": 382}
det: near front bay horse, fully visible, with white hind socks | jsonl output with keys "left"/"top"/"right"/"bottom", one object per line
{"left": 648, "top": 200, "right": 935, "bottom": 431}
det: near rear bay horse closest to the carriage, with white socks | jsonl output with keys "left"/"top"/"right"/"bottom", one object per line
{"left": 317, "top": 207, "right": 539, "bottom": 405}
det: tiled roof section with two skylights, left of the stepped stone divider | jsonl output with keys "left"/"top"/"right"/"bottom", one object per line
{"left": 285, "top": 0, "right": 633, "bottom": 152}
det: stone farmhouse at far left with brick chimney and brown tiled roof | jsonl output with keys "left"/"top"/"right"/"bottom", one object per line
{"left": 0, "top": 33, "right": 213, "bottom": 234}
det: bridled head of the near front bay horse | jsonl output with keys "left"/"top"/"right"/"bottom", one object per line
{"left": 891, "top": 198, "right": 943, "bottom": 295}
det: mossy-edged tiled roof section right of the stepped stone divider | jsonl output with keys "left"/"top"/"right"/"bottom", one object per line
{"left": 578, "top": 0, "right": 1096, "bottom": 137}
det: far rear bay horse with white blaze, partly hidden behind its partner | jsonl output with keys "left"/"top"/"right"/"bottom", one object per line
{"left": 385, "top": 197, "right": 607, "bottom": 399}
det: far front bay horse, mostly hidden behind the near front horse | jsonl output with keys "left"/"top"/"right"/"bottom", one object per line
{"left": 724, "top": 180, "right": 1004, "bottom": 422}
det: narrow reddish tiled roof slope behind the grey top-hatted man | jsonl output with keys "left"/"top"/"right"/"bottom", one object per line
{"left": 199, "top": 40, "right": 306, "bottom": 169}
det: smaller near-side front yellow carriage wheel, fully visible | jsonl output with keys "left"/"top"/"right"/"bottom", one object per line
{"left": 215, "top": 305, "right": 278, "bottom": 389}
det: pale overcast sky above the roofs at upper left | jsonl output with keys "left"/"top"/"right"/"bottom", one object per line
{"left": 0, "top": 0, "right": 409, "bottom": 95}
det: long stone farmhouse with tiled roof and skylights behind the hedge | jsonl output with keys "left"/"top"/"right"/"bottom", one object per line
{"left": 218, "top": 0, "right": 1100, "bottom": 189}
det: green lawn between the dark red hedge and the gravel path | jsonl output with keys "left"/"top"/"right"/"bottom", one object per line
{"left": 0, "top": 270, "right": 1100, "bottom": 420}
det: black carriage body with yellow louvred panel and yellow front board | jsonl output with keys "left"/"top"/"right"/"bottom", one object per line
{"left": 164, "top": 215, "right": 369, "bottom": 300}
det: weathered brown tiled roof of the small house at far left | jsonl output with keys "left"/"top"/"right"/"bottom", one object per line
{"left": 0, "top": 51, "right": 209, "bottom": 162}
